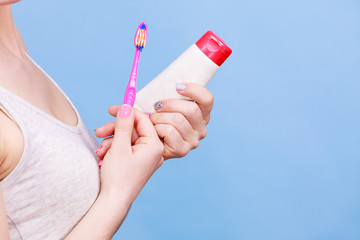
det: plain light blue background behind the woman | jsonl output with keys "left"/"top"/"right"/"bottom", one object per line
{"left": 13, "top": 0, "right": 360, "bottom": 240}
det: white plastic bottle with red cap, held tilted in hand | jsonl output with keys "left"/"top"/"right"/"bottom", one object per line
{"left": 134, "top": 31, "right": 232, "bottom": 113}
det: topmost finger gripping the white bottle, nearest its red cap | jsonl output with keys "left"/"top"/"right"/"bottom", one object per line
{"left": 177, "top": 83, "right": 214, "bottom": 124}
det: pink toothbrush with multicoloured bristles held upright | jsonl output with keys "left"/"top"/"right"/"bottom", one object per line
{"left": 124, "top": 21, "right": 147, "bottom": 107}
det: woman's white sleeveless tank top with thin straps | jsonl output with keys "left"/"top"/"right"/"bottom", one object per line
{"left": 0, "top": 55, "right": 101, "bottom": 240}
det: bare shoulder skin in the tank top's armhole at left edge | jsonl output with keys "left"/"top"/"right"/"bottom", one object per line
{"left": 0, "top": 108, "right": 24, "bottom": 181}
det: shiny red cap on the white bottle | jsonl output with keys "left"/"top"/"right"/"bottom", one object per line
{"left": 196, "top": 31, "right": 232, "bottom": 66}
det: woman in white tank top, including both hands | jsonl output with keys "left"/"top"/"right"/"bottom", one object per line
{"left": 0, "top": 0, "right": 213, "bottom": 240}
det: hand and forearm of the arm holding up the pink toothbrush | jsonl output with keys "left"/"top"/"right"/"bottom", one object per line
{"left": 66, "top": 105, "right": 164, "bottom": 240}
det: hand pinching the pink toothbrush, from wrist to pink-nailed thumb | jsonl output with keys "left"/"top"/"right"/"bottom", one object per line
{"left": 100, "top": 104, "right": 164, "bottom": 201}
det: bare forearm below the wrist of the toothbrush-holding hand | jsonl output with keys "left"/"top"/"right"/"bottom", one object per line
{"left": 66, "top": 190, "right": 133, "bottom": 240}
